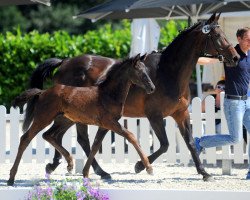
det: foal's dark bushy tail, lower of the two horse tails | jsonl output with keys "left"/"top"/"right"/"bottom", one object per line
{"left": 12, "top": 88, "right": 43, "bottom": 132}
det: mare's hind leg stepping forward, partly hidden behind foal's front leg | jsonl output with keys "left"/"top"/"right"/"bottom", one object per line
{"left": 76, "top": 123, "right": 111, "bottom": 179}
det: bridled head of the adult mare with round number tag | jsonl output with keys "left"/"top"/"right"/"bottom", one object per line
{"left": 199, "top": 14, "right": 239, "bottom": 66}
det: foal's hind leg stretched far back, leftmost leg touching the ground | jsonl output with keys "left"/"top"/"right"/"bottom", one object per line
{"left": 7, "top": 120, "right": 52, "bottom": 185}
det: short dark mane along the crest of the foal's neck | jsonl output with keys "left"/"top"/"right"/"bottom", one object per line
{"left": 96, "top": 58, "right": 133, "bottom": 86}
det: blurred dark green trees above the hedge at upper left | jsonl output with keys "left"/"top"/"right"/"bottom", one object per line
{"left": 0, "top": 0, "right": 109, "bottom": 34}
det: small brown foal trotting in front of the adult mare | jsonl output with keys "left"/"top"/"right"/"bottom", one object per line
{"left": 8, "top": 54, "right": 155, "bottom": 185}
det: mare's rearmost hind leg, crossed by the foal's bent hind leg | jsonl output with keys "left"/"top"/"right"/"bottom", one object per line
{"left": 44, "top": 115, "right": 74, "bottom": 174}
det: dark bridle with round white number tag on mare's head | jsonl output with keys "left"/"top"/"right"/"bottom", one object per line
{"left": 200, "top": 23, "right": 231, "bottom": 62}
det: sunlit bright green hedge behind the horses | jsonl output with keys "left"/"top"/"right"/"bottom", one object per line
{"left": 0, "top": 20, "right": 185, "bottom": 108}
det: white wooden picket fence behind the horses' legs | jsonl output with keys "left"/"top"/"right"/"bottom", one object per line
{"left": 0, "top": 94, "right": 248, "bottom": 173}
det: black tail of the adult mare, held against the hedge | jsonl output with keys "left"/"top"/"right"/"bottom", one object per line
{"left": 30, "top": 58, "right": 63, "bottom": 89}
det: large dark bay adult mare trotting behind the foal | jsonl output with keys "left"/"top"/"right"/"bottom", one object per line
{"left": 28, "top": 14, "right": 239, "bottom": 180}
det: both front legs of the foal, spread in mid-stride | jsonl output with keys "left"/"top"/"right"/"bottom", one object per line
{"left": 83, "top": 119, "right": 153, "bottom": 177}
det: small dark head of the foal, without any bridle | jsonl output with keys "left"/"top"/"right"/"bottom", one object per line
{"left": 128, "top": 54, "right": 155, "bottom": 94}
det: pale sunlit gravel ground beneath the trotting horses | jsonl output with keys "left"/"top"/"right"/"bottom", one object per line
{"left": 0, "top": 160, "right": 250, "bottom": 192}
